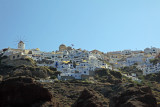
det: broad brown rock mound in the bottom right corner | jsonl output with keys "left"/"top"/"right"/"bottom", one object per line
{"left": 110, "top": 85, "right": 157, "bottom": 107}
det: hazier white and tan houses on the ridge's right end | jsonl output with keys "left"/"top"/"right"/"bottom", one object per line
{"left": 107, "top": 47, "right": 160, "bottom": 75}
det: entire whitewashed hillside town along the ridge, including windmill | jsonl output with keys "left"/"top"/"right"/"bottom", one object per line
{"left": 0, "top": 41, "right": 160, "bottom": 80}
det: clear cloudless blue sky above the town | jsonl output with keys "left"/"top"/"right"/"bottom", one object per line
{"left": 0, "top": 0, "right": 160, "bottom": 52}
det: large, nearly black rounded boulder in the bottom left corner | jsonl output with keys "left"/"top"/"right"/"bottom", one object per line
{"left": 0, "top": 77, "right": 53, "bottom": 107}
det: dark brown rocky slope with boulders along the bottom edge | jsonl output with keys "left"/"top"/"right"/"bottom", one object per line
{"left": 0, "top": 77, "right": 157, "bottom": 107}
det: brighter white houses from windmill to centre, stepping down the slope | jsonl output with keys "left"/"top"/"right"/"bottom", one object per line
{"left": 0, "top": 41, "right": 108, "bottom": 80}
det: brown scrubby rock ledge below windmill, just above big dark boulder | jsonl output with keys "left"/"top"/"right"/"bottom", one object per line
{"left": 0, "top": 65, "right": 55, "bottom": 79}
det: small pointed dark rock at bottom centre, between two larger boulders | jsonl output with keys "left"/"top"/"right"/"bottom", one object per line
{"left": 73, "top": 89, "right": 106, "bottom": 107}
